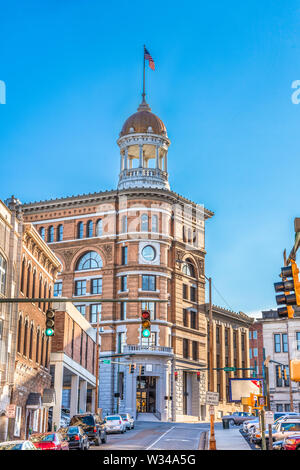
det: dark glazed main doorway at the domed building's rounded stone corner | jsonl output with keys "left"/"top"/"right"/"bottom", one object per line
{"left": 136, "top": 376, "right": 156, "bottom": 413}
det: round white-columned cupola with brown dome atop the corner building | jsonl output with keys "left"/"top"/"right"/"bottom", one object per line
{"left": 117, "top": 97, "right": 170, "bottom": 189}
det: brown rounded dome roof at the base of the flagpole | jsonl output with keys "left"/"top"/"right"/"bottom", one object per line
{"left": 120, "top": 101, "right": 167, "bottom": 137}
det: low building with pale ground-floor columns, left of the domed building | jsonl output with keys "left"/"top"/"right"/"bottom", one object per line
{"left": 50, "top": 302, "right": 96, "bottom": 428}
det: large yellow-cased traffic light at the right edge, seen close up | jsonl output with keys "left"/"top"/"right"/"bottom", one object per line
{"left": 274, "top": 260, "right": 300, "bottom": 318}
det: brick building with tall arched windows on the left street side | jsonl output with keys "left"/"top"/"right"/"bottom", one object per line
{"left": 9, "top": 218, "right": 61, "bottom": 439}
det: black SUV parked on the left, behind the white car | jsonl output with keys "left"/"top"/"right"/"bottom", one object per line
{"left": 70, "top": 413, "right": 107, "bottom": 446}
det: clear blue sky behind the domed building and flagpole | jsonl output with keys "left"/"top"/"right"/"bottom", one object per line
{"left": 0, "top": 0, "right": 300, "bottom": 313}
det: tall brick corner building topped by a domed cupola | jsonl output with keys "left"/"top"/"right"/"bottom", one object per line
{"left": 17, "top": 93, "right": 250, "bottom": 420}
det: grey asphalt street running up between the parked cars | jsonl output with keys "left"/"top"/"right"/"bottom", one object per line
{"left": 90, "top": 421, "right": 209, "bottom": 450}
